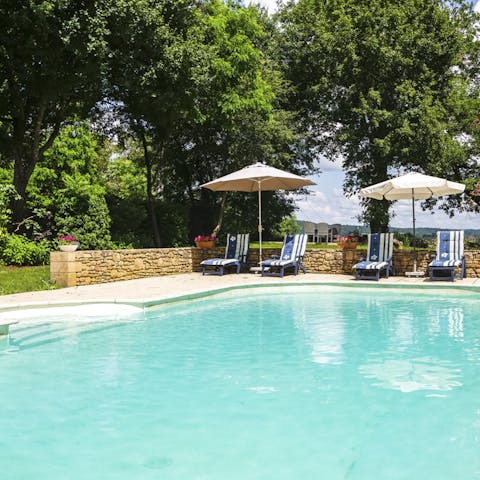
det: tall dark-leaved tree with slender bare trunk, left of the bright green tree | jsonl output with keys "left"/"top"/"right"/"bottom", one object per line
{"left": 107, "top": 0, "right": 198, "bottom": 246}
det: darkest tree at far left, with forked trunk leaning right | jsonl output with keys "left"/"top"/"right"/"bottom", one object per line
{"left": 0, "top": 0, "right": 107, "bottom": 229}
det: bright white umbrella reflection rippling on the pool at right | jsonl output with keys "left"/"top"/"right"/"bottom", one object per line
{"left": 358, "top": 357, "right": 462, "bottom": 393}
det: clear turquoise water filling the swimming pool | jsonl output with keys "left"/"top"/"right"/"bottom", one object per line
{"left": 0, "top": 287, "right": 480, "bottom": 480}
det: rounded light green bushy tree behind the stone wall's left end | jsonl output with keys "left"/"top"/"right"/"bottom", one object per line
{"left": 27, "top": 123, "right": 111, "bottom": 249}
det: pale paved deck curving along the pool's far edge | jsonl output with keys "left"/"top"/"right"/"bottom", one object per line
{"left": 0, "top": 273, "right": 480, "bottom": 313}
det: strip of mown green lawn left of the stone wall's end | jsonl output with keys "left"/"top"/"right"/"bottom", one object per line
{"left": 0, "top": 265, "right": 58, "bottom": 295}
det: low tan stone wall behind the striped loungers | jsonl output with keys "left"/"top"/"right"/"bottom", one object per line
{"left": 50, "top": 247, "right": 480, "bottom": 287}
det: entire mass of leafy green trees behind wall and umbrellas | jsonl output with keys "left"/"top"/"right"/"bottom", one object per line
{"left": 0, "top": 0, "right": 480, "bottom": 258}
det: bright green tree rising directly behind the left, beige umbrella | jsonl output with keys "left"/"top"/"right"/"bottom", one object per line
{"left": 159, "top": 1, "right": 311, "bottom": 240}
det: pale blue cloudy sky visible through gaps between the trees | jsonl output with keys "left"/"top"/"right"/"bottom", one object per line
{"left": 252, "top": 0, "right": 480, "bottom": 229}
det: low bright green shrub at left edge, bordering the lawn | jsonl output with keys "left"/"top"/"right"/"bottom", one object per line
{"left": 0, "top": 235, "right": 50, "bottom": 266}
